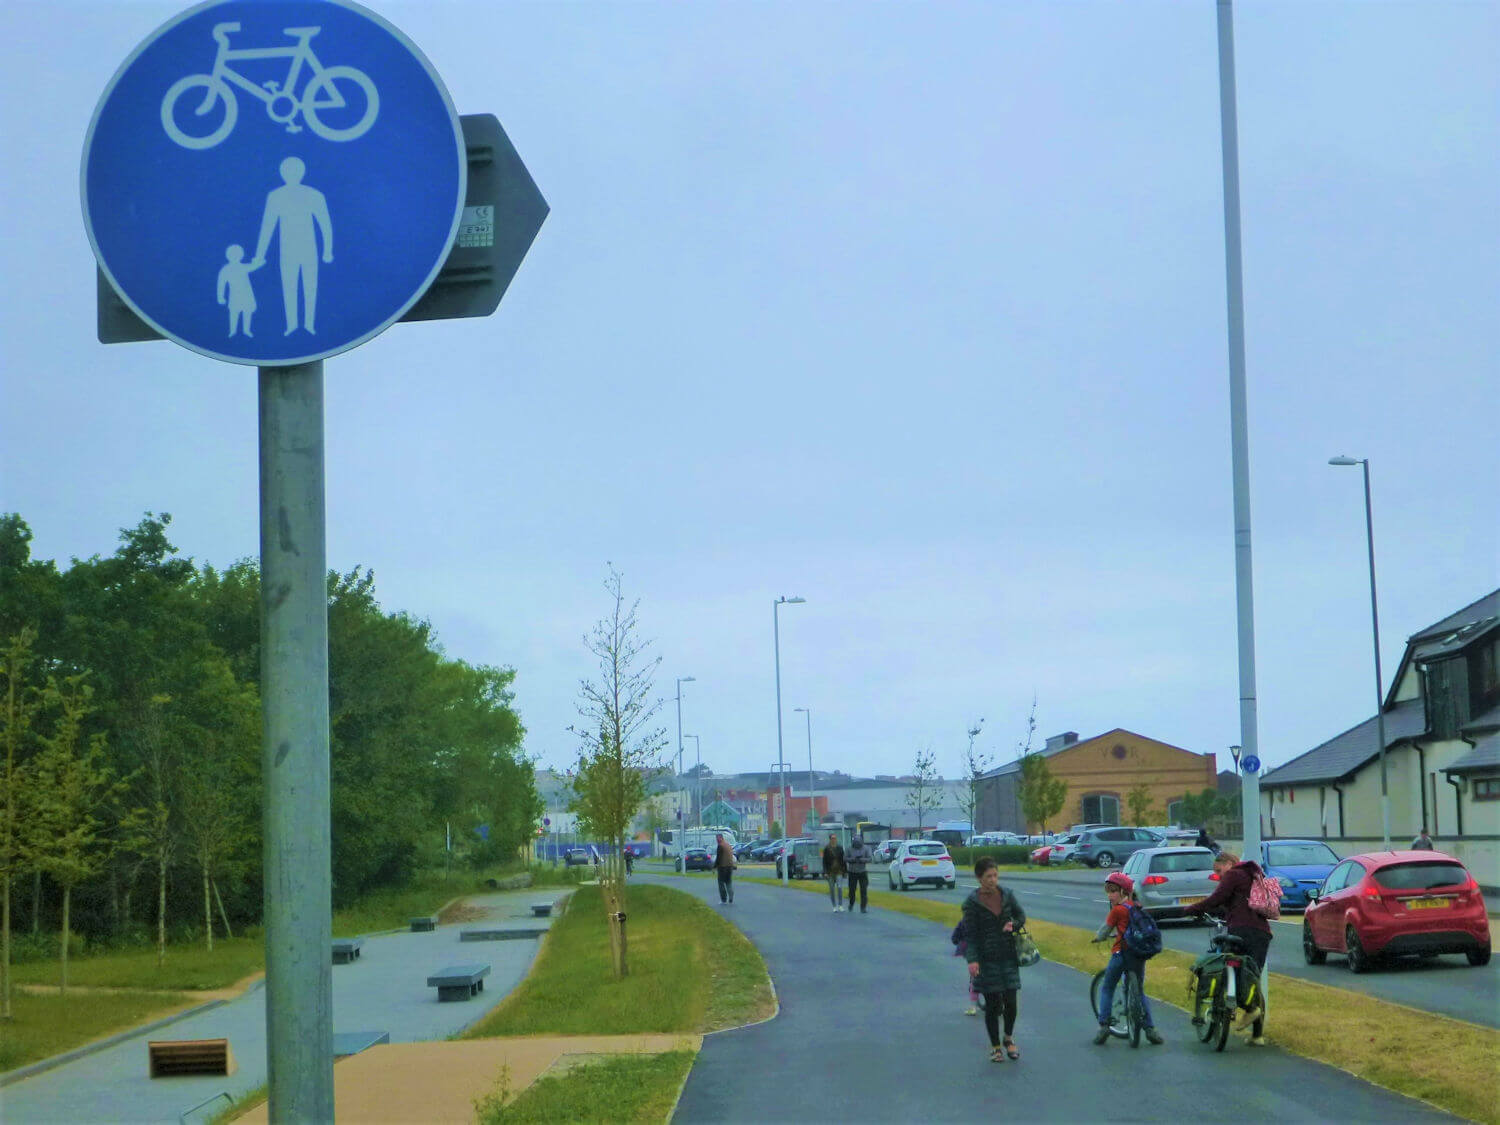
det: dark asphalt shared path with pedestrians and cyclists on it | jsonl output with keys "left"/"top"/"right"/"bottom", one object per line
{"left": 636, "top": 875, "right": 1455, "bottom": 1125}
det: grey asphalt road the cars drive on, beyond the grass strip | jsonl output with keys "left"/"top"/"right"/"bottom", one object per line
{"left": 912, "top": 869, "right": 1500, "bottom": 1028}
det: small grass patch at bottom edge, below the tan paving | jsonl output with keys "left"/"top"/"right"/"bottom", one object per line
{"left": 474, "top": 1050, "right": 696, "bottom": 1125}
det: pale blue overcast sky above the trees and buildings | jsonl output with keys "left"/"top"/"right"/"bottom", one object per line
{"left": 0, "top": 0, "right": 1500, "bottom": 776}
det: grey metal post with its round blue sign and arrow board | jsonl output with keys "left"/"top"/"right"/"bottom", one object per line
{"left": 81, "top": 0, "right": 548, "bottom": 1122}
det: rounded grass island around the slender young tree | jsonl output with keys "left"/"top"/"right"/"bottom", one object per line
{"left": 464, "top": 885, "right": 776, "bottom": 1040}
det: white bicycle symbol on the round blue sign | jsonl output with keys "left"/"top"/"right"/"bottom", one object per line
{"left": 162, "top": 23, "right": 380, "bottom": 149}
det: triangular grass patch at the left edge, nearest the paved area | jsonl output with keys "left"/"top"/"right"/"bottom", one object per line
{"left": 0, "top": 990, "right": 194, "bottom": 1071}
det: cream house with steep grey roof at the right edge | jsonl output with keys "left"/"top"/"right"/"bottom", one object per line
{"left": 1260, "top": 590, "right": 1500, "bottom": 887}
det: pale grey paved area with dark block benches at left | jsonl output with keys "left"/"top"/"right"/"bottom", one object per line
{"left": 0, "top": 887, "right": 567, "bottom": 1125}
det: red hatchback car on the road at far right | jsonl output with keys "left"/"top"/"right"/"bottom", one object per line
{"left": 1302, "top": 852, "right": 1490, "bottom": 972}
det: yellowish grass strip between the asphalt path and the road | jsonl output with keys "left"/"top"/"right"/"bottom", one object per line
{"left": 750, "top": 879, "right": 1500, "bottom": 1125}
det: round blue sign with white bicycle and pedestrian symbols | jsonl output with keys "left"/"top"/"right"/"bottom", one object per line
{"left": 81, "top": 0, "right": 467, "bottom": 366}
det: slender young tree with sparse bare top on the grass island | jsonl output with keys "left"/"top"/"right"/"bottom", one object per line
{"left": 569, "top": 566, "right": 668, "bottom": 977}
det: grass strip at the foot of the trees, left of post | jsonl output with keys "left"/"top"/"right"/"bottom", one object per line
{"left": 12, "top": 935, "right": 266, "bottom": 992}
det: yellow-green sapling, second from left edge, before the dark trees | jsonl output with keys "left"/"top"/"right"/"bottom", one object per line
{"left": 24, "top": 677, "right": 125, "bottom": 993}
